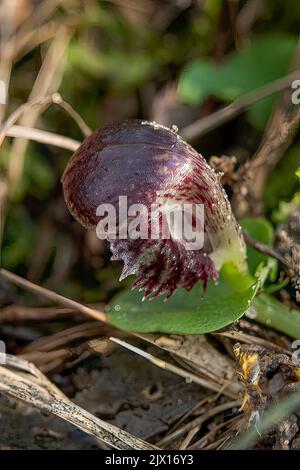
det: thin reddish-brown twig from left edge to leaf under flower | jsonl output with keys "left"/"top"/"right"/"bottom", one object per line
{"left": 0, "top": 269, "right": 107, "bottom": 322}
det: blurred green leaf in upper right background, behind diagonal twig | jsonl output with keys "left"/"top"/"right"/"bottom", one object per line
{"left": 178, "top": 34, "right": 297, "bottom": 129}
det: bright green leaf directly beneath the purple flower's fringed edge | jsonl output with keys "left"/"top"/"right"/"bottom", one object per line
{"left": 107, "top": 265, "right": 259, "bottom": 334}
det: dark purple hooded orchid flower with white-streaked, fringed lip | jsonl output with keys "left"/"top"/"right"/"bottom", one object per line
{"left": 62, "top": 120, "right": 245, "bottom": 298}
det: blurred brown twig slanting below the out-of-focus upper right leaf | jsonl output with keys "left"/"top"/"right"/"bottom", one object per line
{"left": 180, "top": 70, "right": 300, "bottom": 142}
